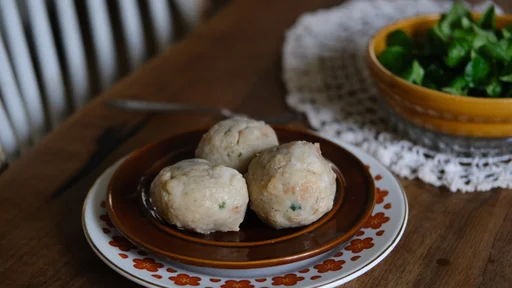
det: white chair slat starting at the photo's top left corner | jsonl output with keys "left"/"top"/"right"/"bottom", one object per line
{"left": 0, "top": 0, "right": 46, "bottom": 142}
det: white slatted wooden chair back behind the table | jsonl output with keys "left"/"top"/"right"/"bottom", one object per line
{"left": 0, "top": 0, "right": 201, "bottom": 160}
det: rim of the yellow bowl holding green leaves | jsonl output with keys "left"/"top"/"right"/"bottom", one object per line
{"left": 368, "top": 13, "right": 512, "bottom": 105}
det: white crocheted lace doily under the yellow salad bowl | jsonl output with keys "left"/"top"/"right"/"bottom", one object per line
{"left": 283, "top": 0, "right": 512, "bottom": 192}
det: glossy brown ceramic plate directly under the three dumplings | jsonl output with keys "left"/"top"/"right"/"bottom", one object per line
{"left": 108, "top": 127, "right": 375, "bottom": 269}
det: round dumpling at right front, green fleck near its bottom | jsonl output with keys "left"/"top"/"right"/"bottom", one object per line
{"left": 246, "top": 141, "right": 336, "bottom": 229}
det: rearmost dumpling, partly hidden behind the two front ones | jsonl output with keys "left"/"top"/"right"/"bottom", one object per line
{"left": 196, "top": 118, "right": 279, "bottom": 173}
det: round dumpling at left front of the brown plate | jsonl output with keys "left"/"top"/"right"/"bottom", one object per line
{"left": 151, "top": 159, "right": 249, "bottom": 234}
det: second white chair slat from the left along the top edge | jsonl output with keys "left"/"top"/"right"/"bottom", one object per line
{"left": 26, "top": 0, "right": 67, "bottom": 128}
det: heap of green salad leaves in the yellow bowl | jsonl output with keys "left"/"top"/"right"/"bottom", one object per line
{"left": 378, "top": 2, "right": 512, "bottom": 98}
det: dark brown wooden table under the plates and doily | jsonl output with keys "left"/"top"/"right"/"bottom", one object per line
{"left": 0, "top": 0, "right": 512, "bottom": 287}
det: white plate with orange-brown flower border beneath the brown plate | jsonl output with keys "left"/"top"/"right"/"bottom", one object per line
{"left": 82, "top": 139, "right": 408, "bottom": 288}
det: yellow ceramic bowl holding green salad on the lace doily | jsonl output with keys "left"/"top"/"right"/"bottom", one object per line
{"left": 368, "top": 14, "right": 512, "bottom": 138}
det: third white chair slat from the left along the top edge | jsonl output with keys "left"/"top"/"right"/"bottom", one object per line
{"left": 55, "top": 0, "right": 89, "bottom": 109}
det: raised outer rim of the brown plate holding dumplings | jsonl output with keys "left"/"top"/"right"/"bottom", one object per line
{"left": 106, "top": 125, "right": 377, "bottom": 269}
